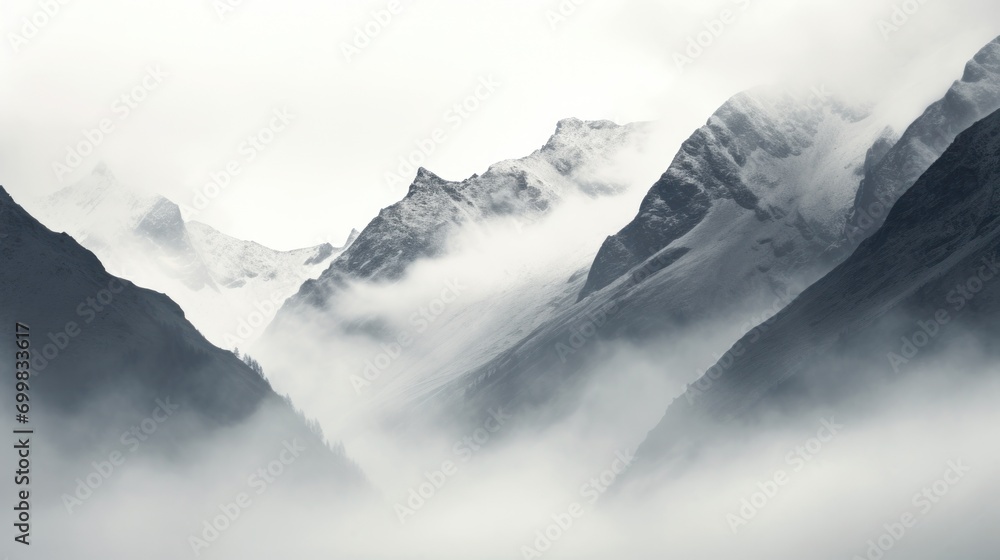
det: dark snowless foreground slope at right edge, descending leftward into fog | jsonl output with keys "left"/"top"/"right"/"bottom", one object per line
{"left": 640, "top": 106, "right": 1000, "bottom": 468}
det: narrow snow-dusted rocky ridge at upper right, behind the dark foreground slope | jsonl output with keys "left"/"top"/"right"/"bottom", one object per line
{"left": 841, "top": 37, "right": 1000, "bottom": 245}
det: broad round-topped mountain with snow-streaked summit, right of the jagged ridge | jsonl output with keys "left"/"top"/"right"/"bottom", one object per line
{"left": 451, "top": 86, "right": 891, "bottom": 420}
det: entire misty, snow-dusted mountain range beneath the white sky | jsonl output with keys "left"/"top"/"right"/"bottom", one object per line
{"left": 0, "top": 29, "right": 1000, "bottom": 557}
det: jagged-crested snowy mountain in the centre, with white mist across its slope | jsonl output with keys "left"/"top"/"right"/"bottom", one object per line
{"left": 255, "top": 119, "right": 659, "bottom": 434}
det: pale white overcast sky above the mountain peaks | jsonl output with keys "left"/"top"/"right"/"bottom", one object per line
{"left": 0, "top": 0, "right": 1000, "bottom": 249}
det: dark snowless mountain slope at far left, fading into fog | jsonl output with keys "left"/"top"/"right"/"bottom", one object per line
{"left": 0, "top": 189, "right": 364, "bottom": 496}
